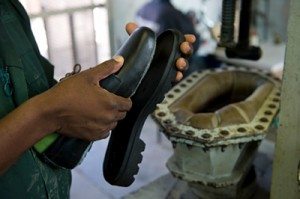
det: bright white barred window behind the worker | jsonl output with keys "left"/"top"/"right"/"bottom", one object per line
{"left": 20, "top": 0, "right": 110, "bottom": 79}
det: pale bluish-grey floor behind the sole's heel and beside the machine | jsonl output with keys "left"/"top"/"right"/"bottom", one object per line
{"left": 71, "top": 117, "right": 274, "bottom": 199}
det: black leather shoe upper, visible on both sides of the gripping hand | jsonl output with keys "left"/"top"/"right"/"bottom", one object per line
{"left": 37, "top": 27, "right": 156, "bottom": 169}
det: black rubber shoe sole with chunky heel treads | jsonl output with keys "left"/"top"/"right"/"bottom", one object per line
{"left": 103, "top": 30, "right": 184, "bottom": 186}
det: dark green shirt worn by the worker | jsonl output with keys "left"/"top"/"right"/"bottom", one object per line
{"left": 0, "top": 0, "right": 71, "bottom": 199}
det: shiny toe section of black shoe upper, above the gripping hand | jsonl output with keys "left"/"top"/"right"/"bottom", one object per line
{"left": 100, "top": 27, "right": 156, "bottom": 97}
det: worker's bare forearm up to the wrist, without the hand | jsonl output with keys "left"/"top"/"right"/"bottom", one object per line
{"left": 0, "top": 96, "right": 55, "bottom": 174}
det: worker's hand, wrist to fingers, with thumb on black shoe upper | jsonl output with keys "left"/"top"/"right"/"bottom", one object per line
{"left": 38, "top": 56, "right": 132, "bottom": 141}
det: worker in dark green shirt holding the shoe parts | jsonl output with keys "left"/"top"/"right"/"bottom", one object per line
{"left": 0, "top": 0, "right": 195, "bottom": 199}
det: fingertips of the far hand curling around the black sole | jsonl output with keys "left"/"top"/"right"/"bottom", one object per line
{"left": 126, "top": 23, "right": 196, "bottom": 81}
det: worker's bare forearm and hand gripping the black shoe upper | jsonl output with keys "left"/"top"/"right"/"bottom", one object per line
{"left": 0, "top": 57, "right": 131, "bottom": 173}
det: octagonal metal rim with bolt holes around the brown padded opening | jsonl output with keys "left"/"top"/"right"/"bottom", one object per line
{"left": 154, "top": 67, "right": 280, "bottom": 147}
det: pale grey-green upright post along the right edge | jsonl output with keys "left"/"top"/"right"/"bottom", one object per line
{"left": 271, "top": 0, "right": 300, "bottom": 199}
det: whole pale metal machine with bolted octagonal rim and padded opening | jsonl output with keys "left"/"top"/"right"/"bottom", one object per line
{"left": 153, "top": 67, "right": 280, "bottom": 198}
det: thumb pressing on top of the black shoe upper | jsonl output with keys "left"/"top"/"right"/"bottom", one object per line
{"left": 91, "top": 55, "right": 124, "bottom": 82}
